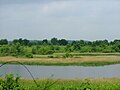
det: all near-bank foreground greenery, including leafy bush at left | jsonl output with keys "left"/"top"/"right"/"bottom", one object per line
{"left": 0, "top": 74, "right": 120, "bottom": 90}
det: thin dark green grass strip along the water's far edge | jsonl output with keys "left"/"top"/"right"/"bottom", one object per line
{"left": 0, "top": 61, "right": 120, "bottom": 66}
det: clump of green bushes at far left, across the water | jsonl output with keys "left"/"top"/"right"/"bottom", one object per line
{"left": 0, "top": 43, "right": 33, "bottom": 58}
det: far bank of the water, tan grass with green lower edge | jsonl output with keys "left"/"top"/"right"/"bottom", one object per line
{"left": 0, "top": 56, "right": 120, "bottom": 66}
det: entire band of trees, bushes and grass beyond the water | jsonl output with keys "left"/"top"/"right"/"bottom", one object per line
{"left": 0, "top": 38, "right": 120, "bottom": 66}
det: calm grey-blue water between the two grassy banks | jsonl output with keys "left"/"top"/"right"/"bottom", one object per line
{"left": 0, "top": 64, "right": 120, "bottom": 79}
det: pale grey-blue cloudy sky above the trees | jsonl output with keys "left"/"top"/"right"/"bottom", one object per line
{"left": 0, "top": 0, "right": 120, "bottom": 40}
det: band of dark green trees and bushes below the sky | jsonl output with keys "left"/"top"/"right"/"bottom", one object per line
{"left": 0, "top": 37, "right": 120, "bottom": 58}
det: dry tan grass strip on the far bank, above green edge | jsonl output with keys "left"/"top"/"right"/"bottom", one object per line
{"left": 0, "top": 56, "right": 120, "bottom": 65}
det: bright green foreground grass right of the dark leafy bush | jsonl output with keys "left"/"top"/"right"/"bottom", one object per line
{"left": 0, "top": 78, "right": 120, "bottom": 90}
